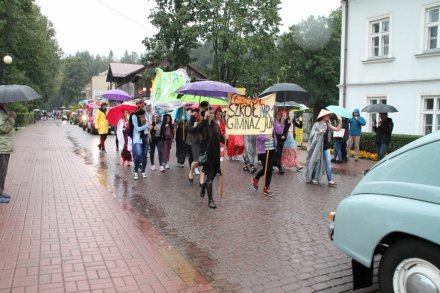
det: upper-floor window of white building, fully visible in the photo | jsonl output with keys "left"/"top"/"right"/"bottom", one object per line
{"left": 370, "top": 18, "right": 390, "bottom": 58}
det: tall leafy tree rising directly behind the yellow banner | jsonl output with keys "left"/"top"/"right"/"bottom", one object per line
{"left": 197, "top": 0, "right": 281, "bottom": 85}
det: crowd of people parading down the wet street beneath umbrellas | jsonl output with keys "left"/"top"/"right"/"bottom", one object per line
{"left": 82, "top": 100, "right": 393, "bottom": 208}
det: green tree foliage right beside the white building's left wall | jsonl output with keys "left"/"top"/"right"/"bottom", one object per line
{"left": 278, "top": 9, "right": 341, "bottom": 110}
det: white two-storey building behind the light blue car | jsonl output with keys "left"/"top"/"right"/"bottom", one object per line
{"left": 339, "top": 0, "right": 440, "bottom": 134}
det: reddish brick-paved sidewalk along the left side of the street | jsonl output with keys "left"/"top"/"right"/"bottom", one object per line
{"left": 0, "top": 123, "right": 215, "bottom": 292}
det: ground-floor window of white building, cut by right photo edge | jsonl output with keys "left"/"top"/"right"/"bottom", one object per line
{"left": 422, "top": 96, "right": 440, "bottom": 135}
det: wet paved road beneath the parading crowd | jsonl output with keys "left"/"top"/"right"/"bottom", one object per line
{"left": 61, "top": 122, "right": 377, "bottom": 292}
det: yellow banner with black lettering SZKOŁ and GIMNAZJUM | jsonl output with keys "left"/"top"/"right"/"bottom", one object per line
{"left": 226, "top": 94, "right": 275, "bottom": 135}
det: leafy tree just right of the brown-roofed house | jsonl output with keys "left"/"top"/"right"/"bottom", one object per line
{"left": 143, "top": 0, "right": 201, "bottom": 69}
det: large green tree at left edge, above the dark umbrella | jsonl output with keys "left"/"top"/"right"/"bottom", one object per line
{"left": 0, "top": 0, "right": 62, "bottom": 108}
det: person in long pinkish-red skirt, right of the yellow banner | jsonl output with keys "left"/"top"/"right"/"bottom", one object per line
{"left": 281, "top": 110, "right": 303, "bottom": 172}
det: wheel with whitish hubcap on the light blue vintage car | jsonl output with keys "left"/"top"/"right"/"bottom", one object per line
{"left": 378, "top": 238, "right": 440, "bottom": 293}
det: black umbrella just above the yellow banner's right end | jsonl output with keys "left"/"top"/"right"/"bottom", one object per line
{"left": 260, "top": 83, "right": 310, "bottom": 105}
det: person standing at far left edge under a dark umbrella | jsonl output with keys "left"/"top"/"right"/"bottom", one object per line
{"left": 0, "top": 103, "right": 17, "bottom": 203}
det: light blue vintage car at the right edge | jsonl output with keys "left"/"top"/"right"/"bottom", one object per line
{"left": 329, "top": 131, "right": 440, "bottom": 293}
